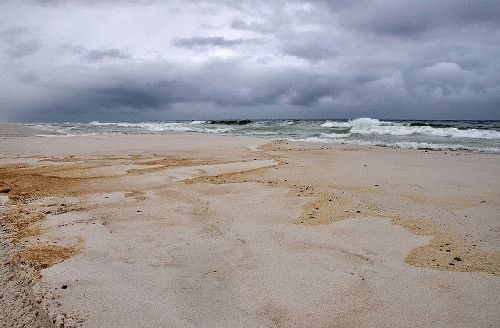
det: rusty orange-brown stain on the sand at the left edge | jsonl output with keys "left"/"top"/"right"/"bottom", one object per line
{"left": 0, "top": 155, "right": 235, "bottom": 272}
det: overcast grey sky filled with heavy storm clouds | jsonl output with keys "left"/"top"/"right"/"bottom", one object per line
{"left": 0, "top": 0, "right": 500, "bottom": 122}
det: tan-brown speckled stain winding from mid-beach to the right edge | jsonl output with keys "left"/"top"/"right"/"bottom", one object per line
{"left": 184, "top": 141, "right": 500, "bottom": 276}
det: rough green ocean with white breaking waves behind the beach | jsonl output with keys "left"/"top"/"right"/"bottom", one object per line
{"left": 28, "top": 118, "right": 500, "bottom": 154}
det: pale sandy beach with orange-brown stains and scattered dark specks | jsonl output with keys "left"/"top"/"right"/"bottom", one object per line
{"left": 0, "top": 125, "right": 500, "bottom": 327}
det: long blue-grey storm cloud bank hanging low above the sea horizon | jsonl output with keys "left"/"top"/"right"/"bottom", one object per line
{"left": 15, "top": 46, "right": 500, "bottom": 121}
